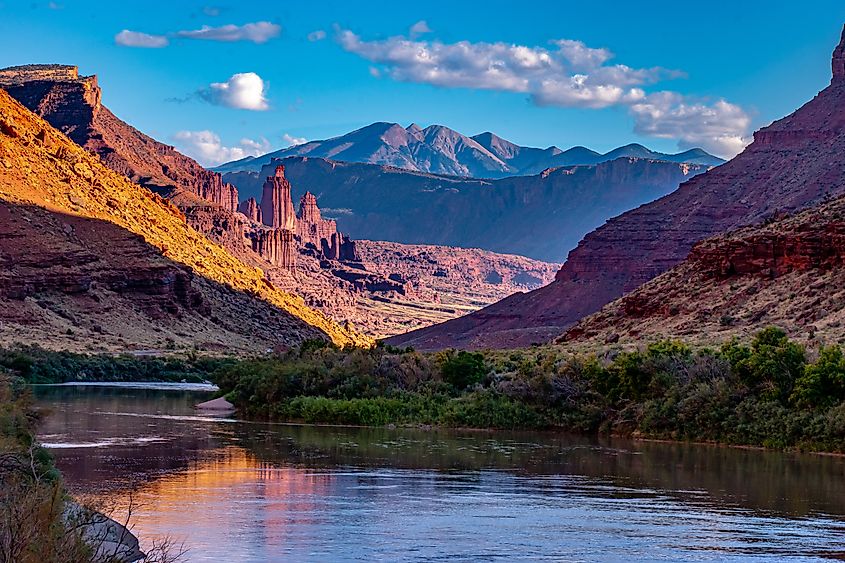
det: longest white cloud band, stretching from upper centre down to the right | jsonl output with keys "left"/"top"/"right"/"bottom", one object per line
{"left": 337, "top": 29, "right": 751, "bottom": 157}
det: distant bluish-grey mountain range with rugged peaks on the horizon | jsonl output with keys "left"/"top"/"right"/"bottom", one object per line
{"left": 214, "top": 122, "right": 725, "bottom": 178}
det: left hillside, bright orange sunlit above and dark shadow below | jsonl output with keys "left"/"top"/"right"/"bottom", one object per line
{"left": 0, "top": 90, "right": 368, "bottom": 351}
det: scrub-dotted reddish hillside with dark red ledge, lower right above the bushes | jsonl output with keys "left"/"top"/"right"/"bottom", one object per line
{"left": 558, "top": 194, "right": 845, "bottom": 344}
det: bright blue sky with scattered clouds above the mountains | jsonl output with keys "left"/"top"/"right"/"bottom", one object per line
{"left": 0, "top": 0, "right": 845, "bottom": 164}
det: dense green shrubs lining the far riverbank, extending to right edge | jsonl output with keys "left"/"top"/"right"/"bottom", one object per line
{"left": 214, "top": 328, "right": 845, "bottom": 453}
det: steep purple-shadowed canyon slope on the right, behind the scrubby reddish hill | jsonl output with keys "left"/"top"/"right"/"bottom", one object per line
{"left": 392, "top": 28, "right": 845, "bottom": 348}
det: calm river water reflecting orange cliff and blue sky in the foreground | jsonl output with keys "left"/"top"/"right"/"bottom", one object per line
{"left": 31, "top": 386, "right": 845, "bottom": 562}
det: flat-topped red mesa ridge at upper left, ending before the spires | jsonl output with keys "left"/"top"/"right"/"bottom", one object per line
{"left": 0, "top": 65, "right": 238, "bottom": 211}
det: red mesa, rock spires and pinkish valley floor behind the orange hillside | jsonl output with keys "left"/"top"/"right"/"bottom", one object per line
{"left": 0, "top": 65, "right": 557, "bottom": 336}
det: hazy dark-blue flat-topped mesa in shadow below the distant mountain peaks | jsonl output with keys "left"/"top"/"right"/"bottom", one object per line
{"left": 224, "top": 158, "right": 707, "bottom": 262}
